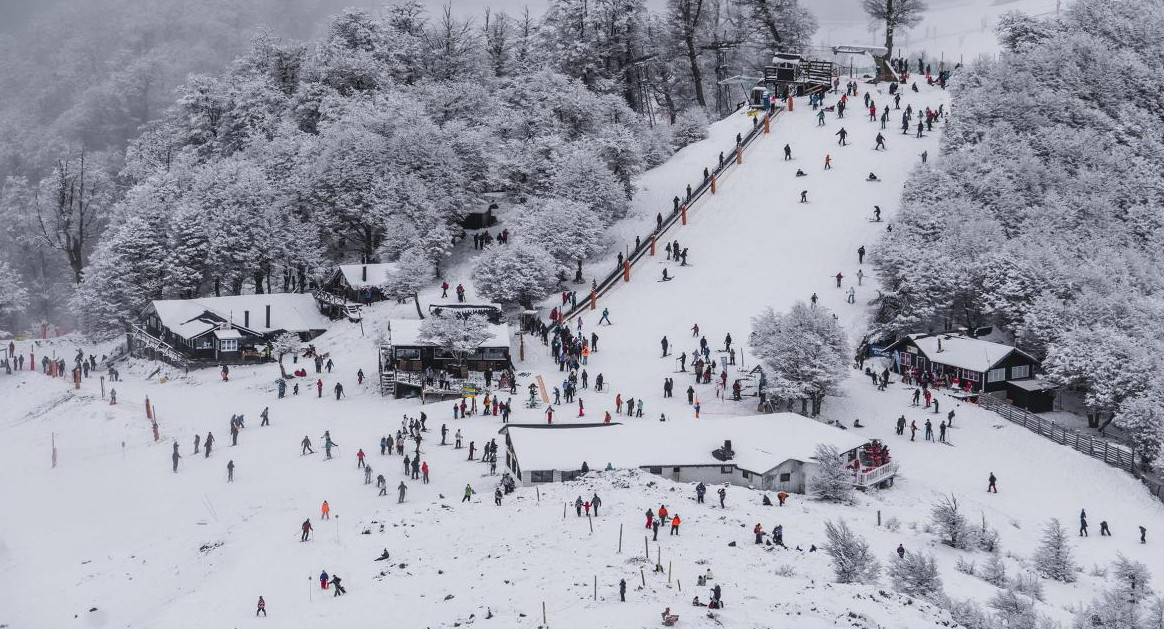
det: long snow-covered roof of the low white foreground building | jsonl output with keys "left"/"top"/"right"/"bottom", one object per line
{"left": 508, "top": 412, "right": 870, "bottom": 474}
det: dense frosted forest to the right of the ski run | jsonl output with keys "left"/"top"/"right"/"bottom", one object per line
{"left": 875, "top": 0, "right": 1164, "bottom": 462}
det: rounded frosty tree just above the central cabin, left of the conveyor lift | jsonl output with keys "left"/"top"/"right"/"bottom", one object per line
{"left": 473, "top": 242, "right": 558, "bottom": 308}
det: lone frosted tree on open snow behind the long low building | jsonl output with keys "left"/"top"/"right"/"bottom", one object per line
{"left": 751, "top": 302, "right": 851, "bottom": 416}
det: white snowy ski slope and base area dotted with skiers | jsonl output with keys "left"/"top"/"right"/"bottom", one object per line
{"left": 0, "top": 75, "right": 1164, "bottom": 629}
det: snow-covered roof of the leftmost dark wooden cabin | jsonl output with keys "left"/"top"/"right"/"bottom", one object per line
{"left": 150, "top": 292, "right": 327, "bottom": 339}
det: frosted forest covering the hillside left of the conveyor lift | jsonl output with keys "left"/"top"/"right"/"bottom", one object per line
{"left": 0, "top": 0, "right": 816, "bottom": 333}
